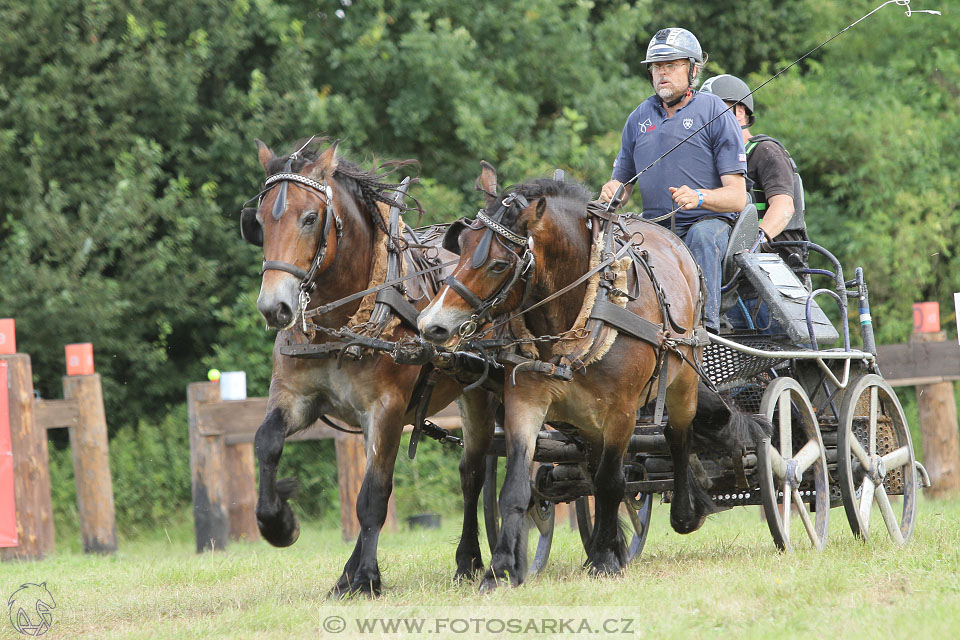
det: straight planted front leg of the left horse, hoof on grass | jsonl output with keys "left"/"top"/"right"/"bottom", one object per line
{"left": 327, "top": 405, "right": 403, "bottom": 598}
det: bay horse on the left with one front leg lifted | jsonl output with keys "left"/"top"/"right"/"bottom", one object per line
{"left": 241, "top": 139, "right": 496, "bottom": 597}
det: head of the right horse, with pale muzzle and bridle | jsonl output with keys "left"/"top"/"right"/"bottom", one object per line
{"left": 417, "top": 162, "right": 547, "bottom": 344}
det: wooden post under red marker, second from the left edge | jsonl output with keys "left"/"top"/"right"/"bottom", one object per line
{"left": 63, "top": 373, "right": 117, "bottom": 553}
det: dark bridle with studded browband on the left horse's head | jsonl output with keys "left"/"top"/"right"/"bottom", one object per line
{"left": 257, "top": 159, "right": 343, "bottom": 324}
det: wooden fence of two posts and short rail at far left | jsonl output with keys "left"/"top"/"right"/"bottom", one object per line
{"left": 0, "top": 345, "right": 117, "bottom": 560}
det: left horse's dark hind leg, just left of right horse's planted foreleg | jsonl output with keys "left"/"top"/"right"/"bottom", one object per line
{"left": 454, "top": 389, "right": 498, "bottom": 582}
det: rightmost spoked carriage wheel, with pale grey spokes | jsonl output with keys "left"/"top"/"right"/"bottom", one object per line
{"left": 837, "top": 374, "right": 917, "bottom": 545}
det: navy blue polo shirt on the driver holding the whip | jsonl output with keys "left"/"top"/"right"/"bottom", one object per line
{"left": 613, "top": 91, "right": 747, "bottom": 235}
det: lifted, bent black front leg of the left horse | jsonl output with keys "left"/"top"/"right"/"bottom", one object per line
{"left": 253, "top": 408, "right": 300, "bottom": 547}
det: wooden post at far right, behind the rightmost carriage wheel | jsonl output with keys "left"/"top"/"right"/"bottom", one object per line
{"left": 910, "top": 331, "right": 960, "bottom": 498}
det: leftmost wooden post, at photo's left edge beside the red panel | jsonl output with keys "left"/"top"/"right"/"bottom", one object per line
{"left": 0, "top": 353, "right": 54, "bottom": 560}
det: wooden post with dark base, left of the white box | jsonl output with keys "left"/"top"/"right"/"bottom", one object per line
{"left": 187, "top": 382, "right": 229, "bottom": 553}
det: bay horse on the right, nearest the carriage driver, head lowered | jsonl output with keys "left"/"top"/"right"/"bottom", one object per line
{"left": 418, "top": 163, "right": 762, "bottom": 591}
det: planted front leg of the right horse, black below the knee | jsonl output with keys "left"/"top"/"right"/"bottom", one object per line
{"left": 480, "top": 398, "right": 547, "bottom": 593}
